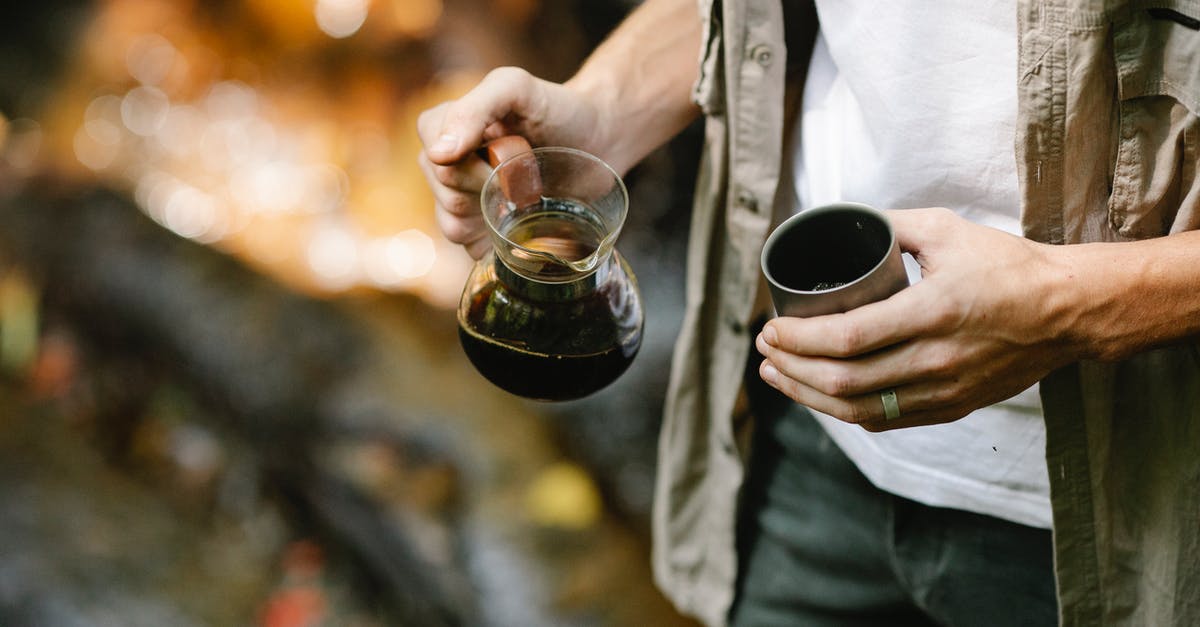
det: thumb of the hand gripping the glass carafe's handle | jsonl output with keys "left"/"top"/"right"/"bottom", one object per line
{"left": 421, "top": 67, "right": 536, "bottom": 166}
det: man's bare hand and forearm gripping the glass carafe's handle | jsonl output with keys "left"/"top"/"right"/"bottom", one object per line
{"left": 418, "top": 0, "right": 701, "bottom": 258}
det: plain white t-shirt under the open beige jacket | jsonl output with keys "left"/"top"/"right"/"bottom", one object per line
{"left": 792, "top": 0, "right": 1050, "bottom": 527}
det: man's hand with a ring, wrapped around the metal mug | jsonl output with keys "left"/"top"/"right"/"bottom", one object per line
{"left": 757, "top": 209, "right": 1082, "bottom": 431}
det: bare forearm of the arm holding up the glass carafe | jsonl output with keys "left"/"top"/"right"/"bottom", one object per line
{"left": 566, "top": 0, "right": 701, "bottom": 172}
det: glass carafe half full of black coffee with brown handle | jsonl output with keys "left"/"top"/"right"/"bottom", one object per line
{"left": 458, "top": 137, "right": 643, "bottom": 401}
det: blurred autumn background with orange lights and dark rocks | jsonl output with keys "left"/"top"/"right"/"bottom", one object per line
{"left": 0, "top": 0, "right": 701, "bottom": 627}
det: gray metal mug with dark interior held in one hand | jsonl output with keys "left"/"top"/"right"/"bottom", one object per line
{"left": 762, "top": 203, "right": 908, "bottom": 317}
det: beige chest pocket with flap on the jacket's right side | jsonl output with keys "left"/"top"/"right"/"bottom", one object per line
{"left": 1109, "top": 10, "right": 1200, "bottom": 239}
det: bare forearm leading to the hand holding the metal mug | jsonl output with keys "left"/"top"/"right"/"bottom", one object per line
{"left": 1050, "top": 231, "right": 1200, "bottom": 359}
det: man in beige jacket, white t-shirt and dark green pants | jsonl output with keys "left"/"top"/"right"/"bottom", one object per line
{"left": 420, "top": 0, "right": 1200, "bottom": 625}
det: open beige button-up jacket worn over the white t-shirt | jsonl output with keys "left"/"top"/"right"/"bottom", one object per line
{"left": 653, "top": 0, "right": 1200, "bottom": 626}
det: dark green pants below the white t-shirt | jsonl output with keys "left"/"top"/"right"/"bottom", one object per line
{"left": 731, "top": 389, "right": 1057, "bottom": 627}
